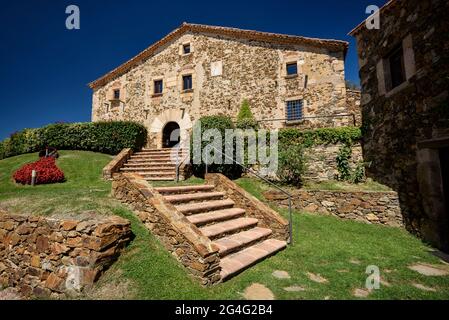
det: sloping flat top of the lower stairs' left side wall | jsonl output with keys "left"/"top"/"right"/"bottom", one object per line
{"left": 123, "top": 173, "right": 218, "bottom": 258}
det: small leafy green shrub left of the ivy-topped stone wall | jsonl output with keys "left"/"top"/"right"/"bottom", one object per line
{"left": 277, "top": 144, "right": 307, "bottom": 187}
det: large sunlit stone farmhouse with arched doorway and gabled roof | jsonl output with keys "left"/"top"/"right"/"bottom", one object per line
{"left": 90, "top": 23, "right": 353, "bottom": 148}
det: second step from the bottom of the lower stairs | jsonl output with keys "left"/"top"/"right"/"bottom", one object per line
{"left": 214, "top": 227, "right": 273, "bottom": 257}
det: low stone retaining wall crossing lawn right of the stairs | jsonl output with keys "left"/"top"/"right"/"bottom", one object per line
{"left": 264, "top": 190, "right": 403, "bottom": 227}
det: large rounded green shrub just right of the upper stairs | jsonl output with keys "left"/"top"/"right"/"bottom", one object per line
{"left": 190, "top": 116, "right": 243, "bottom": 179}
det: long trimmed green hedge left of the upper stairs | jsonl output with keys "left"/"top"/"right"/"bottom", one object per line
{"left": 0, "top": 121, "right": 147, "bottom": 159}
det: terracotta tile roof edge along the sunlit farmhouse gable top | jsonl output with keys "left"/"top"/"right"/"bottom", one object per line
{"left": 89, "top": 22, "right": 349, "bottom": 89}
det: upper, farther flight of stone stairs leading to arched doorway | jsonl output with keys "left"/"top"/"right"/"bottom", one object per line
{"left": 120, "top": 148, "right": 187, "bottom": 181}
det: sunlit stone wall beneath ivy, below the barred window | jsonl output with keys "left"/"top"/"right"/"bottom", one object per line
{"left": 304, "top": 144, "right": 363, "bottom": 182}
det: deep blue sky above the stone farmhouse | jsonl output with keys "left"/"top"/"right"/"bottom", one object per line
{"left": 0, "top": 0, "right": 386, "bottom": 139}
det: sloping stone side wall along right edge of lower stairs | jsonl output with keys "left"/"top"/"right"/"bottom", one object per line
{"left": 205, "top": 173, "right": 289, "bottom": 241}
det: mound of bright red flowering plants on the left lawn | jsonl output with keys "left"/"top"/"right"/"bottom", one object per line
{"left": 13, "top": 157, "right": 65, "bottom": 184}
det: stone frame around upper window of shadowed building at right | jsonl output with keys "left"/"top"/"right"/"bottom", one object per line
{"left": 376, "top": 34, "right": 416, "bottom": 98}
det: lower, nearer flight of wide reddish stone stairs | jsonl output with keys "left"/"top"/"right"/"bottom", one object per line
{"left": 154, "top": 185, "right": 287, "bottom": 281}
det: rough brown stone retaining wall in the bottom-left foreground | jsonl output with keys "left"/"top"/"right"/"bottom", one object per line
{"left": 0, "top": 213, "right": 131, "bottom": 298}
